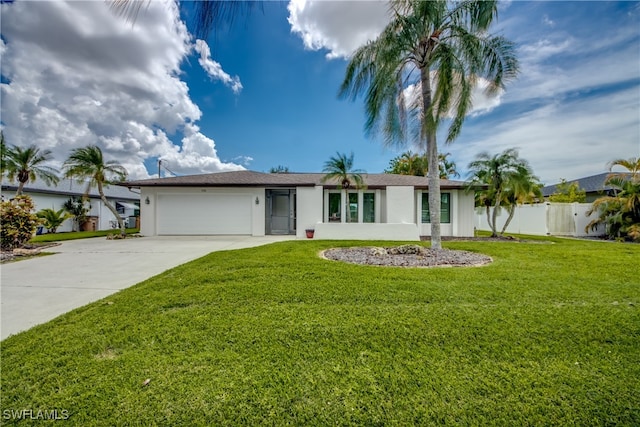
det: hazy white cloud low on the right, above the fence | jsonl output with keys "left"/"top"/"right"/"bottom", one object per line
{"left": 450, "top": 88, "right": 640, "bottom": 184}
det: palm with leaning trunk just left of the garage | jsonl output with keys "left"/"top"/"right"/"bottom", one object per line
{"left": 63, "top": 145, "right": 127, "bottom": 236}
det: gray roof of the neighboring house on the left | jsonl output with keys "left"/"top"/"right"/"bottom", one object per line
{"left": 2, "top": 178, "right": 140, "bottom": 201}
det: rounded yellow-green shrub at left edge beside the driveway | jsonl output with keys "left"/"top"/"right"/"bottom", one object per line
{"left": 0, "top": 195, "right": 40, "bottom": 250}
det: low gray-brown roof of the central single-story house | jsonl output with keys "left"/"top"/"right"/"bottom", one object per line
{"left": 119, "top": 170, "right": 465, "bottom": 189}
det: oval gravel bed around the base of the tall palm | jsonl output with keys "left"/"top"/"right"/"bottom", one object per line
{"left": 320, "top": 245, "right": 493, "bottom": 267}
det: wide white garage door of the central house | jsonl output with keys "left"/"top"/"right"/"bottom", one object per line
{"left": 157, "top": 194, "right": 252, "bottom": 235}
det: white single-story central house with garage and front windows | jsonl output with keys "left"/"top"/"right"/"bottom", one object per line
{"left": 120, "top": 171, "right": 474, "bottom": 240}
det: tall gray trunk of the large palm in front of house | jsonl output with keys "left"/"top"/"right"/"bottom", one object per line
{"left": 420, "top": 67, "right": 442, "bottom": 249}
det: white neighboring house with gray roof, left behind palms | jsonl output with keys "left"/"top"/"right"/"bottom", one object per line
{"left": 2, "top": 178, "right": 140, "bottom": 232}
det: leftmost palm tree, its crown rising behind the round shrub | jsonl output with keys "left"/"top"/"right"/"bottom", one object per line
{"left": 3, "top": 145, "right": 60, "bottom": 196}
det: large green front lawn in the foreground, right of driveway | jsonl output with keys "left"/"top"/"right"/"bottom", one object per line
{"left": 1, "top": 239, "right": 640, "bottom": 426}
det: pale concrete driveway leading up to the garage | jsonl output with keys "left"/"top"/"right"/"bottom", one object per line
{"left": 0, "top": 236, "right": 295, "bottom": 339}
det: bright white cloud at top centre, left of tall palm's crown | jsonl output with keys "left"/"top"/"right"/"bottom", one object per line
{"left": 288, "top": 0, "right": 389, "bottom": 59}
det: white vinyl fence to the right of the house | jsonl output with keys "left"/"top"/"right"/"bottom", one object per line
{"left": 476, "top": 202, "right": 604, "bottom": 237}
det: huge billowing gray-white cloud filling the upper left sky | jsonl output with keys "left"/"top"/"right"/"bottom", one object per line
{"left": 0, "top": 0, "right": 242, "bottom": 179}
